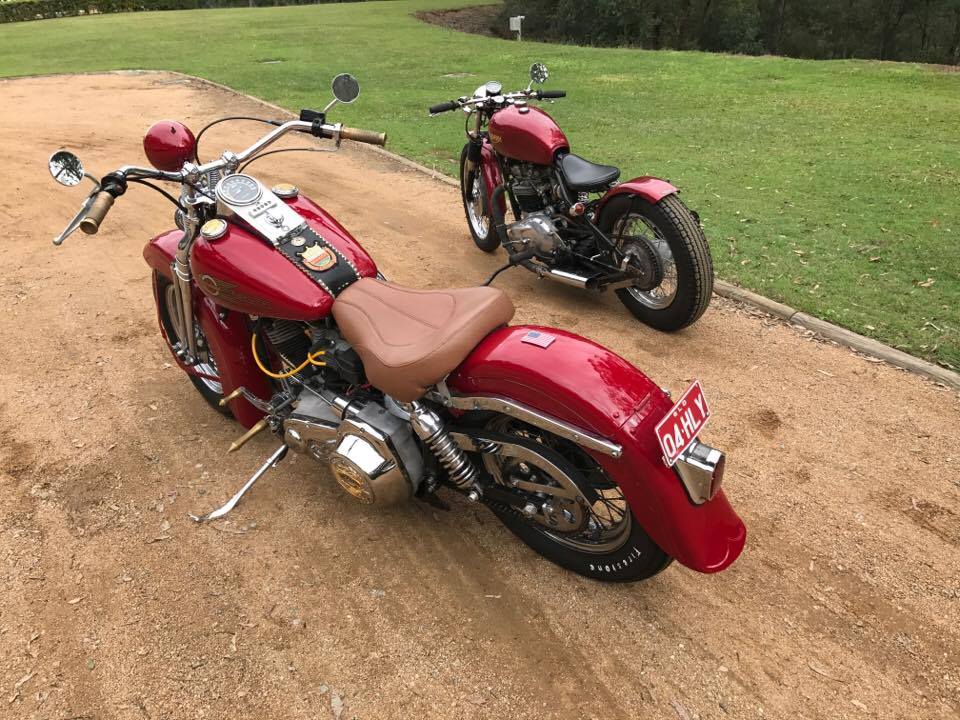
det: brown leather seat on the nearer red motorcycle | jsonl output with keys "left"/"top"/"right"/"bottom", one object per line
{"left": 333, "top": 278, "right": 513, "bottom": 402}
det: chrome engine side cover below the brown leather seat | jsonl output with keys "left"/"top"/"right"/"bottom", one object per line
{"left": 283, "top": 392, "right": 424, "bottom": 505}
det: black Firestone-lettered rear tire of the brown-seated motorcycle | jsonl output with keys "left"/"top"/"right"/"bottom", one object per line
{"left": 464, "top": 414, "right": 673, "bottom": 582}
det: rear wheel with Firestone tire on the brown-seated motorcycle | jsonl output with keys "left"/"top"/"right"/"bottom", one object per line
{"left": 483, "top": 416, "right": 672, "bottom": 582}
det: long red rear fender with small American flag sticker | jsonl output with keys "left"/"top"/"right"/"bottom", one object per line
{"left": 447, "top": 326, "right": 746, "bottom": 572}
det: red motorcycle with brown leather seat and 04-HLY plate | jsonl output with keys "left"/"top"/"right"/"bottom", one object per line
{"left": 50, "top": 75, "right": 745, "bottom": 581}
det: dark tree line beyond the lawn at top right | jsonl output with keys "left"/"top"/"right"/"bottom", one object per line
{"left": 496, "top": 0, "right": 960, "bottom": 65}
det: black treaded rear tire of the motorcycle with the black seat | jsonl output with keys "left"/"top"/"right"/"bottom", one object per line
{"left": 600, "top": 195, "right": 713, "bottom": 332}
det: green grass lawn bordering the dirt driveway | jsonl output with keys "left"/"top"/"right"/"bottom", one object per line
{"left": 0, "top": 0, "right": 960, "bottom": 368}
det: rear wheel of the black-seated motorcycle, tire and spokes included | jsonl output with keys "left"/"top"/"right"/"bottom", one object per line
{"left": 601, "top": 195, "right": 713, "bottom": 331}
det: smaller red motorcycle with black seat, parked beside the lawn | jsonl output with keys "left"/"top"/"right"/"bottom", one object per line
{"left": 430, "top": 63, "right": 713, "bottom": 330}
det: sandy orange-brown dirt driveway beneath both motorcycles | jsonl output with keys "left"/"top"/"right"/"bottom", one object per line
{"left": 0, "top": 73, "right": 960, "bottom": 720}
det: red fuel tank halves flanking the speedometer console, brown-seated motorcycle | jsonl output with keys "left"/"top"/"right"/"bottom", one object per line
{"left": 191, "top": 191, "right": 377, "bottom": 321}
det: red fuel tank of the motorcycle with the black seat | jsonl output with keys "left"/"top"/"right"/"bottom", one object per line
{"left": 489, "top": 105, "right": 570, "bottom": 165}
